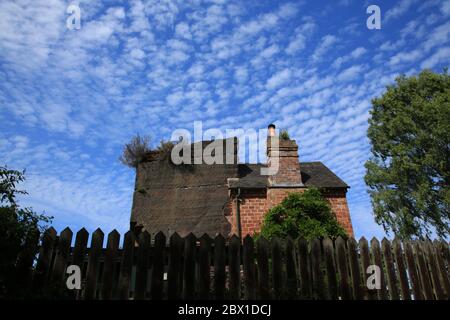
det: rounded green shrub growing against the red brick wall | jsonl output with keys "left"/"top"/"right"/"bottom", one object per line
{"left": 261, "top": 188, "right": 347, "bottom": 239}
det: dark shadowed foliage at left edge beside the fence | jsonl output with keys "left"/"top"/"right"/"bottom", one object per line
{"left": 0, "top": 167, "right": 52, "bottom": 297}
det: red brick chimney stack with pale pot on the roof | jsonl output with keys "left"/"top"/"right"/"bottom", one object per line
{"left": 267, "top": 124, "right": 303, "bottom": 187}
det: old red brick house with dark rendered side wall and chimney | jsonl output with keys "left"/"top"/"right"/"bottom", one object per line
{"left": 130, "top": 125, "right": 353, "bottom": 236}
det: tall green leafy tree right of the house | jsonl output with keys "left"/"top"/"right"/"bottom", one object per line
{"left": 365, "top": 70, "right": 450, "bottom": 238}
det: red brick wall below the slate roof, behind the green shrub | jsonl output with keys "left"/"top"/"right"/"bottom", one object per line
{"left": 228, "top": 188, "right": 353, "bottom": 237}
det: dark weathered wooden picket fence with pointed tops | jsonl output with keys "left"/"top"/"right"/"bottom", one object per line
{"left": 31, "top": 228, "right": 450, "bottom": 300}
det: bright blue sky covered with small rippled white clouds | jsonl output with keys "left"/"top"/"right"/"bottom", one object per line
{"left": 0, "top": 0, "right": 450, "bottom": 238}
